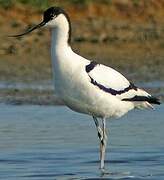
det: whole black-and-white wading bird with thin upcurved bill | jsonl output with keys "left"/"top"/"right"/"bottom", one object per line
{"left": 10, "top": 6, "right": 160, "bottom": 173}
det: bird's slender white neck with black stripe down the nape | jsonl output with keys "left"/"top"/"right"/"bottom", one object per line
{"left": 51, "top": 14, "right": 71, "bottom": 56}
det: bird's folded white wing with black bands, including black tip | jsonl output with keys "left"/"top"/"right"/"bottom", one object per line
{"left": 86, "top": 61, "right": 160, "bottom": 104}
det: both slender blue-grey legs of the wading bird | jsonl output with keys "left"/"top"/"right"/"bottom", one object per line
{"left": 93, "top": 116, "right": 107, "bottom": 173}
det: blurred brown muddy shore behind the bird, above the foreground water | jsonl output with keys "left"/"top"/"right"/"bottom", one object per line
{"left": 0, "top": 0, "right": 164, "bottom": 104}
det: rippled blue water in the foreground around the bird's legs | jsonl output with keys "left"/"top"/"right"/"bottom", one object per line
{"left": 0, "top": 104, "right": 164, "bottom": 180}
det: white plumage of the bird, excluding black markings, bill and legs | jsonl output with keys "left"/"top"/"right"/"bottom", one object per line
{"left": 48, "top": 14, "right": 150, "bottom": 118}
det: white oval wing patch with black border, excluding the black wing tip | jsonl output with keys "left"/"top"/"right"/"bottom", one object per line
{"left": 86, "top": 62, "right": 137, "bottom": 95}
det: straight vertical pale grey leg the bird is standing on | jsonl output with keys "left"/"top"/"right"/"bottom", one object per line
{"left": 100, "top": 118, "right": 107, "bottom": 173}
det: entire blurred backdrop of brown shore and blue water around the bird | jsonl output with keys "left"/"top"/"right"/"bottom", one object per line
{"left": 0, "top": 0, "right": 164, "bottom": 180}
